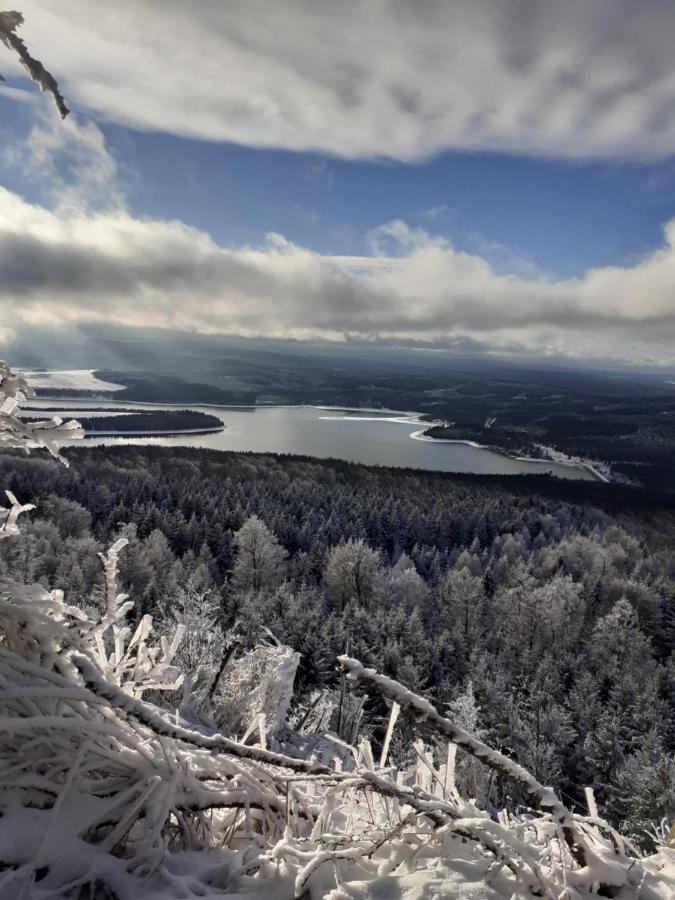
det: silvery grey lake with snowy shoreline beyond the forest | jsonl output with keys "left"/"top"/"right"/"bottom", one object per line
{"left": 24, "top": 398, "right": 595, "bottom": 481}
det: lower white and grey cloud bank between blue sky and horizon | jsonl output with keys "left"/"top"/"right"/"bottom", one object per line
{"left": 0, "top": 189, "right": 675, "bottom": 365}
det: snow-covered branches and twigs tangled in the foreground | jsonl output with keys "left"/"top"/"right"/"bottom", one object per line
{"left": 0, "top": 540, "right": 672, "bottom": 900}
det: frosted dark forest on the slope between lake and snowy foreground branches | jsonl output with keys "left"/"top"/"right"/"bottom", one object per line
{"left": 0, "top": 448, "right": 675, "bottom": 848}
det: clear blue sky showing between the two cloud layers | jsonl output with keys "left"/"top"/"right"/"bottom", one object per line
{"left": 5, "top": 97, "right": 675, "bottom": 278}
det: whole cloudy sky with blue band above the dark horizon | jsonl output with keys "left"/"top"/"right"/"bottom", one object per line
{"left": 0, "top": 0, "right": 675, "bottom": 370}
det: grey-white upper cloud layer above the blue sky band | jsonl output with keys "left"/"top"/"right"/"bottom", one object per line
{"left": 2, "top": 0, "right": 675, "bottom": 160}
